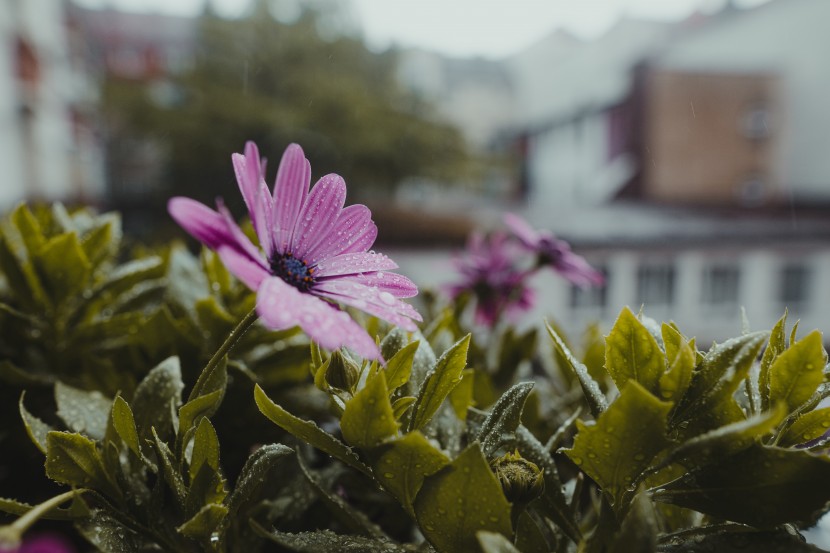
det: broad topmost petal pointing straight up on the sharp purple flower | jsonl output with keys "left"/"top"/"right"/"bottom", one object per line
{"left": 274, "top": 144, "right": 311, "bottom": 254}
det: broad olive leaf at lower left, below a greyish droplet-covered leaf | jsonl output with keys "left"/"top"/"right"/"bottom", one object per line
{"left": 46, "top": 431, "right": 121, "bottom": 498}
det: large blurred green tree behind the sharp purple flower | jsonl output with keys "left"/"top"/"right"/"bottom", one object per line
{"left": 104, "top": 0, "right": 472, "bottom": 222}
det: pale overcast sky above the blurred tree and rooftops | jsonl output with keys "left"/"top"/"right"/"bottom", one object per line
{"left": 77, "top": 0, "right": 786, "bottom": 58}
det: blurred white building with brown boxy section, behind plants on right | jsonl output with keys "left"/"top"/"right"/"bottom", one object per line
{"left": 396, "top": 0, "right": 830, "bottom": 344}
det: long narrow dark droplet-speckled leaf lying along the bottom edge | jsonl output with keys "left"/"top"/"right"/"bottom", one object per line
{"left": 251, "top": 521, "right": 410, "bottom": 553}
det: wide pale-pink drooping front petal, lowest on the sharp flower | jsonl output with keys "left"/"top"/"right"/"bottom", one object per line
{"left": 257, "top": 277, "right": 382, "bottom": 359}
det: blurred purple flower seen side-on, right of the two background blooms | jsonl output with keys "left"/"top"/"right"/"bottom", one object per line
{"left": 504, "top": 213, "right": 605, "bottom": 287}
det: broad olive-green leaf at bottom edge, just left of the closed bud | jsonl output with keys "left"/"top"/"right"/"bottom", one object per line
{"left": 414, "top": 443, "right": 513, "bottom": 553}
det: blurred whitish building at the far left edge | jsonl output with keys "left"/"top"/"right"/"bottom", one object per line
{"left": 0, "top": 0, "right": 104, "bottom": 210}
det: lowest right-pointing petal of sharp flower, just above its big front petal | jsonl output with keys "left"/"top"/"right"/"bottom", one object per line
{"left": 314, "top": 279, "right": 422, "bottom": 332}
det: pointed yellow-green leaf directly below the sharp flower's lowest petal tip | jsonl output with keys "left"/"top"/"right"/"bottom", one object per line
{"left": 340, "top": 368, "right": 400, "bottom": 448}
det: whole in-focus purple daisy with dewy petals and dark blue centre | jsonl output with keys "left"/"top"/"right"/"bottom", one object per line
{"left": 168, "top": 142, "right": 422, "bottom": 359}
